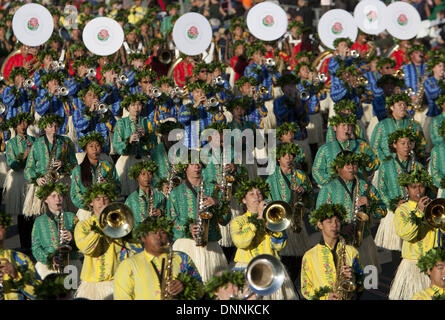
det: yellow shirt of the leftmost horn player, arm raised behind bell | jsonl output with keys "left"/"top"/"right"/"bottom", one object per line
{"left": 74, "top": 216, "right": 141, "bottom": 282}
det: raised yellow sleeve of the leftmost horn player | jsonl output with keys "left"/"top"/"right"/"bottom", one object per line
{"left": 74, "top": 217, "right": 106, "bottom": 256}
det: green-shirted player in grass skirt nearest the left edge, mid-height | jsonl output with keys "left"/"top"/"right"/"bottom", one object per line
{"left": 2, "top": 113, "right": 35, "bottom": 249}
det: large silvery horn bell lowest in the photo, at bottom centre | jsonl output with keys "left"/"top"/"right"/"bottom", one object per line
{"left": 244, "top": 254, "right": 285, "bottom": 299}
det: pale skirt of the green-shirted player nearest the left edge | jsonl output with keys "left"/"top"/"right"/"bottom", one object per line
{"left": 2, "top": 169, "right": 27, "bottom": 217}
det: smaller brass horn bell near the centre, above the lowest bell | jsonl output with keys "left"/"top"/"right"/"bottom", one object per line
{"left": 263, "top": 201, "right": 292, "bottom": 232}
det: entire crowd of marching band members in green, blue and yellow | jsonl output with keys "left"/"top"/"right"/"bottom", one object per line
{"left": 0, "top": 1, "right": 445, "bottom": 300}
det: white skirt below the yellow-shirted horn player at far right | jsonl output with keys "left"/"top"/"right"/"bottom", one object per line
{"left": 389, "top": 259, "right": 431, "bottom": 300}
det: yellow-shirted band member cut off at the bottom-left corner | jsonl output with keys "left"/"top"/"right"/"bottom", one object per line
{"left": 0, "top": 212, "right": 39, "bottom": 300}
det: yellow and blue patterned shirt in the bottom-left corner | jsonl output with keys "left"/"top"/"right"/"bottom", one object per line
{"left": 0, "top": 249, "right": 40, "bottom": 300}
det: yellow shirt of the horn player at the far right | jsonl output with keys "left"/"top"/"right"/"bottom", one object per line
{"left": 394, "top": 200, "right": 440, "bottom": 260}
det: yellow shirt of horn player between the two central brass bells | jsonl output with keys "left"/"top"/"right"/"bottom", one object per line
{"left": 230, "top": 211, "right": 287, "bottom": 264}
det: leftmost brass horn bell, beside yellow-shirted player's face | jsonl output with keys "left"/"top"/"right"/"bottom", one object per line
{"left": 99, "top": 202, "right": 134, "bottom": 239}
